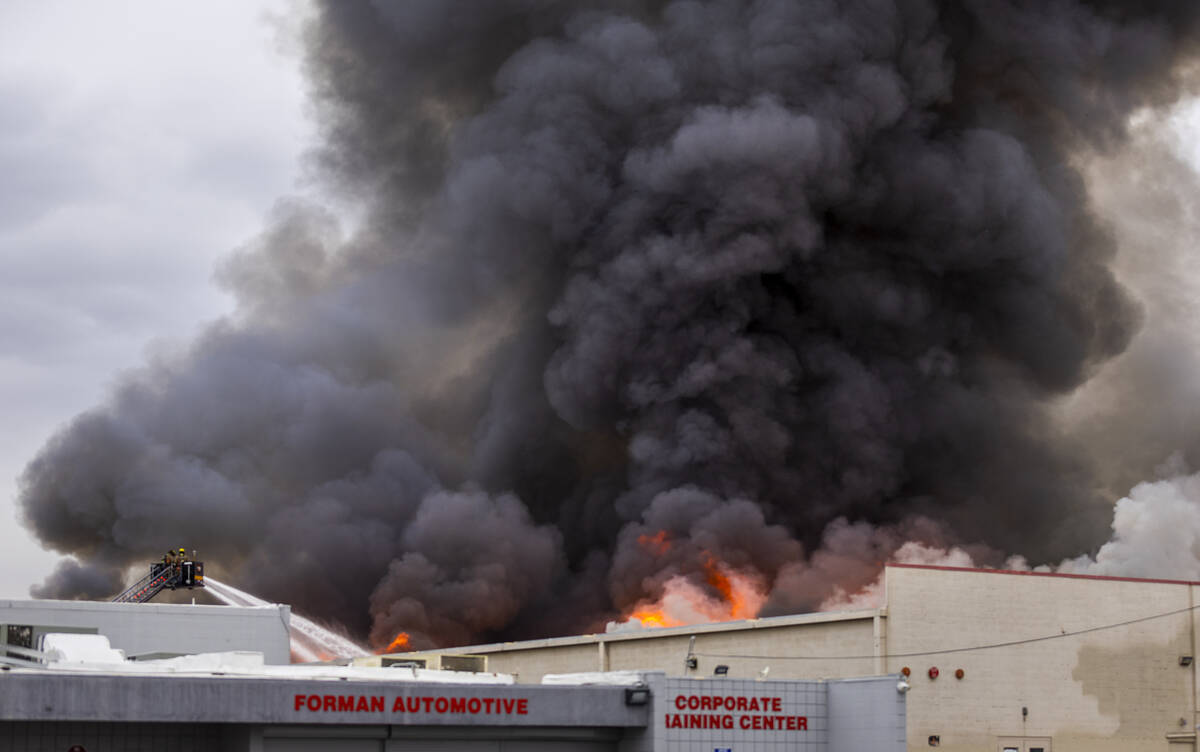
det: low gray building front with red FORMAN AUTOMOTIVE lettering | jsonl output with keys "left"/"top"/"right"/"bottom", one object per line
{"left": 0, "top": 668, "right": 905, "bottom": 752}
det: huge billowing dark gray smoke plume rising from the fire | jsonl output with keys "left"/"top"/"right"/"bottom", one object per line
{"left": 22, "top": 0, "right": 1200, "bottom": 645}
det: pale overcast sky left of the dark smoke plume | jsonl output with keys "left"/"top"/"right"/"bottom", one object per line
{"left": 0, "top": 0, "right": 312, "bottom": 597}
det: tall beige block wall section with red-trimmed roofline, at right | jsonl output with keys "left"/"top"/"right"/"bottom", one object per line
{"left": 886, "top": 567, "right": 1196, "bottom": 752}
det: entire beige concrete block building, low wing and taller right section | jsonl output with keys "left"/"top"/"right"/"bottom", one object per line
{"left": 397, "top": 565, "right": 1200, "bottom": 752}
